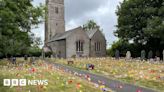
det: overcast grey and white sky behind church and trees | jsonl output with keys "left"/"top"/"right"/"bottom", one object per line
{"left": 32, "top": 0, "right": 123, "bottom": 47}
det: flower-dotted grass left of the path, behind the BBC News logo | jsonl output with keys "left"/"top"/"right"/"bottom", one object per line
{"left": 0, "top": 59, "right": 111, "bottom": 92}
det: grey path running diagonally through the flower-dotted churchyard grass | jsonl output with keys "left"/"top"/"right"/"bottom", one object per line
{"left": 48, "top": 63, "right": 157, "bottom": 92}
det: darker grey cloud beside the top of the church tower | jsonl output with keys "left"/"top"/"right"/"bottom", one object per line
{"left": 65, "top": 0, "right": 108, "bottom": 21}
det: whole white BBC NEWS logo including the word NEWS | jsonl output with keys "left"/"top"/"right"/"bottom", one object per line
{"left": 3, "top": 79, "right": 48, "bottom": 86}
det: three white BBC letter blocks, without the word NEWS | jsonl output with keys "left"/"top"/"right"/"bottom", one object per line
{"left": 3, "top": 79, "right": 26, "bottom": 86}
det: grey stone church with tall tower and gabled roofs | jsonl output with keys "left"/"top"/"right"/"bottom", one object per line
{"left": 45, "top": 0, "right": 106, "bottom": 58}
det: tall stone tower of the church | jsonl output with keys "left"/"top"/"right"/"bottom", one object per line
{"left": 45, "top": 0, "right": 65, "bottom": 43}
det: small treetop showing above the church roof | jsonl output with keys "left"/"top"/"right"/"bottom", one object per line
{"left": 83, "top": 20, "right": 101, "bottom": 31}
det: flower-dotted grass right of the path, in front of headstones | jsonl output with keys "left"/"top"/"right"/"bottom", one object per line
{"left": 50, "top": 58, "right": 164, "bottom": 92}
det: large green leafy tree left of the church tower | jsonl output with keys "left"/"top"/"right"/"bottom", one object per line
{"left": 0, "top": 0, "right": 44, "bottom": 57}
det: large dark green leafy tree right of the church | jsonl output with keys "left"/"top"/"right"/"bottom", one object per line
{"left": 115, "top": 0, "right": 164, "bottom": 45}
